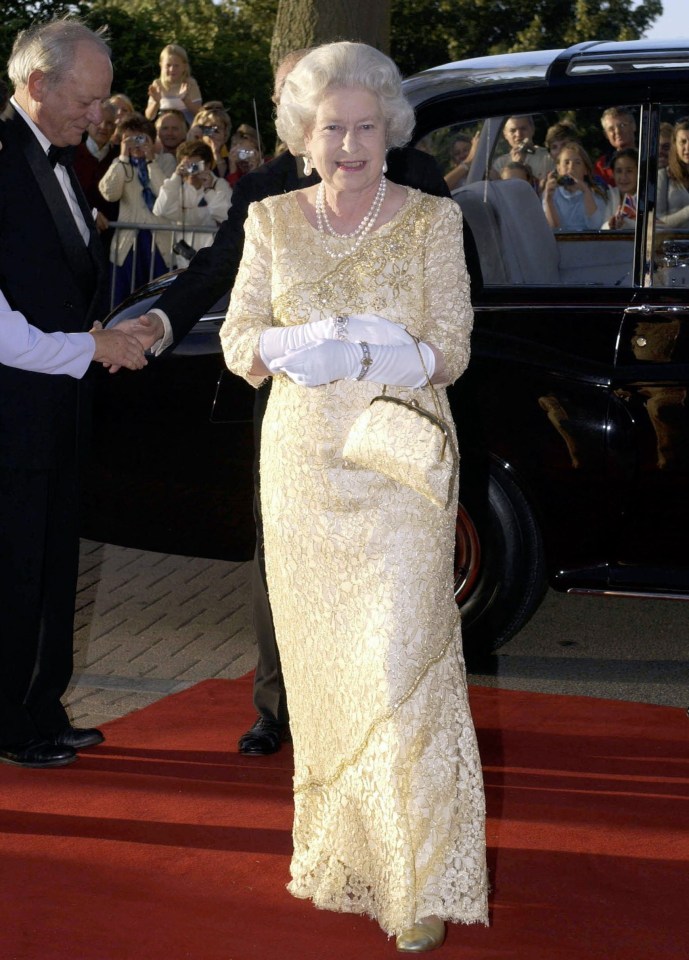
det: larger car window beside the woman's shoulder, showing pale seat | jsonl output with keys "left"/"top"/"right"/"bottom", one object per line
{"left": 416, "top": 103, "right": 640, "bottom": 287}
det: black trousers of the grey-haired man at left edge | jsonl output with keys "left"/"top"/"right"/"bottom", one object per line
{"left": 0, "top": 456, "right": 79, "bottom": 744}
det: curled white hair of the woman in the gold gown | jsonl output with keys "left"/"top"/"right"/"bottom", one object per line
{"left": 275, "top": 41, "right": 414, "bottom": 154}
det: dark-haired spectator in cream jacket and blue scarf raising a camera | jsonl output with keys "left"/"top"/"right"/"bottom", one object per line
{"left": 98, "top": 113, "right": 170, "bottom": 303}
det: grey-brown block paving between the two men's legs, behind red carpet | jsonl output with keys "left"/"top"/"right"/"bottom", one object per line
{"left": 65, "top": 540, "right": 256, "bottom": 726}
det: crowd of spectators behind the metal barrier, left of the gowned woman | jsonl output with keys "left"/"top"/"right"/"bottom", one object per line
{"left": 0, "top": 43, "right": 265, "bottom": 302}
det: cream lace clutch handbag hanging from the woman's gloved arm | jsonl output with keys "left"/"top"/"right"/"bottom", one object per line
{"left": 342, "top": 338, "right": 459, "bottom": 510}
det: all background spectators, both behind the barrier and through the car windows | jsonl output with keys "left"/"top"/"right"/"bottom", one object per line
{"left": 5, "top": 43, "right": 689, "bottom": 302}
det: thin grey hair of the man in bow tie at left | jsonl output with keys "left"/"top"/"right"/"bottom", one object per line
{"left": 7, "top": 17, "right": 110, "bottom": 89}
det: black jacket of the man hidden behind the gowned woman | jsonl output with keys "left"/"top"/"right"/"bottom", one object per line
{"left": 154, "top": 147, "right": 476, "bottom": 344}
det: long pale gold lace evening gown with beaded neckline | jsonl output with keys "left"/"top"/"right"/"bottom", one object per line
{"left": 221, "top": 190, "right": 488, "bottom": 935}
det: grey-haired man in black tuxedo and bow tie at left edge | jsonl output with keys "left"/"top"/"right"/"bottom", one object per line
{"left": 0, "top": 20, "right": 143, "bottom": 767}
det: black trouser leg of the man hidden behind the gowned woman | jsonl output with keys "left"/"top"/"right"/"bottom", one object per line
{"left": 251, "top": 381, "right": 289, "bottom": 725}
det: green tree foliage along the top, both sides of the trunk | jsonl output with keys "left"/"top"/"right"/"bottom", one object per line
{"left": 0, "top": 0, "right": 662, "bottom": 118}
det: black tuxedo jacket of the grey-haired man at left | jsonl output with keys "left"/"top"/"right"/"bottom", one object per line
{"left": 0, "top": 111, "right": 107, "bottom": 470}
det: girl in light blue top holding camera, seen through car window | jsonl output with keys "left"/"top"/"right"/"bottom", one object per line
{"left": 543, "top": 142, "right": 606, "bottom": 230}
